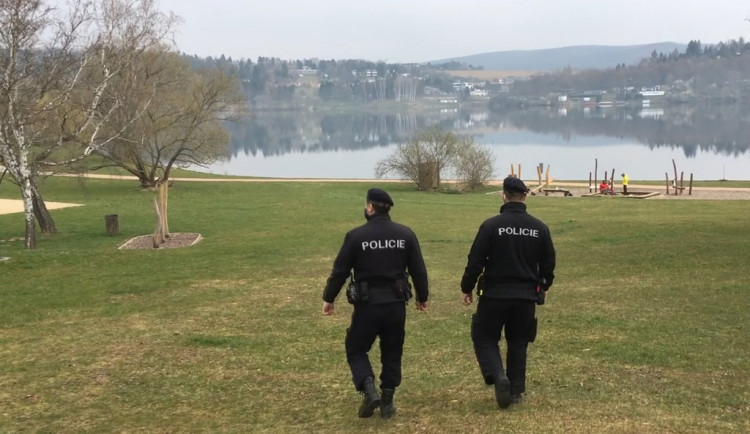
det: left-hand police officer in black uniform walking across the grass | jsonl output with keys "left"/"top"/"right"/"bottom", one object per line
{"left": 323, "top": 188, "right": 428, "bottom": 419}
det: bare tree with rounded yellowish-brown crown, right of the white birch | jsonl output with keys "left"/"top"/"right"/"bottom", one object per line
{"left": 90, "top": 48, "right": 244, "bottom": 187}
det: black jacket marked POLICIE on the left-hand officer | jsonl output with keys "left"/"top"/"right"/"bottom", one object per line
{"left": 323, "top": 214, "right": 428, "bottom": 303}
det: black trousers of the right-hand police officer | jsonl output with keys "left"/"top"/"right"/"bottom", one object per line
{"left": 471, "top": 297, "right": 536, "bottom": 394}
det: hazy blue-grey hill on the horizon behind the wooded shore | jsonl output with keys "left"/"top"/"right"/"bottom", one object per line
{"left": 430, "top": 42, "right": 687, "bottom": 71}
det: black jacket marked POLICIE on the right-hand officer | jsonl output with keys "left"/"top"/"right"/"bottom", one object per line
{"left": 461, "top": 202, "right": 555, "bottom": 300}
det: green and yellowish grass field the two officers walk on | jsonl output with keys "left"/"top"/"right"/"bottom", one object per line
{"left": 0, "top": 178, "right": 750, "bottom": 433}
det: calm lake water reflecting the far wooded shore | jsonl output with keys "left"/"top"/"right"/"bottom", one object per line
{"left": 197, "top": 108, "right": 750, "bottom": 180}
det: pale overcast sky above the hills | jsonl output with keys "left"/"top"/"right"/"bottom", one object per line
{"left": 158, "top": 0, "right": 750, "bottom": 63}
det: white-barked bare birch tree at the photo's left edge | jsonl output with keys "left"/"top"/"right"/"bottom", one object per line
{"left": 0, "top": 0, "right": 176, "bottom": 249}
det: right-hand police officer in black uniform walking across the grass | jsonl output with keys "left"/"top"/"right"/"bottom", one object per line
{"left": 461, "top": 177, "right": 555, "bottom": 408}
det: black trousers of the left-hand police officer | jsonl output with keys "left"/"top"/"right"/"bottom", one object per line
{"left": 345, "top": 301, "right": 406, "bottom": 390}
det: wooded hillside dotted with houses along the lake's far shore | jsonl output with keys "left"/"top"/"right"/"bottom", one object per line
{"left": 182, "top": 38, "right": 750, "bottom": 109}
